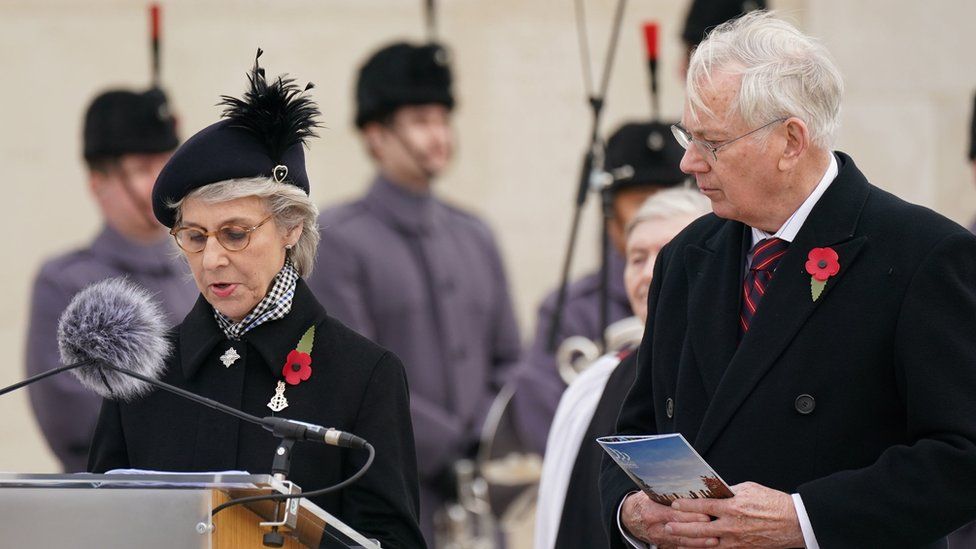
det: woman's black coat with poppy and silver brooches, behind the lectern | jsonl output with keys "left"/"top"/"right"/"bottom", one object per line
{"left": 89, "top": 280, "right": 425, "bottom": 548}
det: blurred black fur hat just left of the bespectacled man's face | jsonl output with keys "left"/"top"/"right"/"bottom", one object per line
{"left": 604, "top": 122, "right": 688, "bottom": 192}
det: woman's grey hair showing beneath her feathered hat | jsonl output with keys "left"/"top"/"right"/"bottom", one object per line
{"left": 169, "top": 177, "right": 319, "bottom": 278}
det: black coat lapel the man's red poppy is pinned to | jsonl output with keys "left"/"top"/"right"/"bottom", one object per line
{"left": 695, "top": 153, "right": 870, "bottom": 453}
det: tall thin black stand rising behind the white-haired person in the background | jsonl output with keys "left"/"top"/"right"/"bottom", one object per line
{"left": 546, "top": 0, "right": 626, "bottom": 353}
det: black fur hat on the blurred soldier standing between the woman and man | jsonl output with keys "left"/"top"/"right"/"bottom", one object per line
{"left": 356, "top": 42, "right": 454, "bottom": 128}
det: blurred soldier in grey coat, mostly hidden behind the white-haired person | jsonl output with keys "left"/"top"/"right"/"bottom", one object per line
{"left": 511, "top": 122, "right": 687, "bottom": 454}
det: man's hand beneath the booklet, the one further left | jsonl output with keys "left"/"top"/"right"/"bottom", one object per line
{"left": 620, "top": 492, "right": 718, "bottom": 548}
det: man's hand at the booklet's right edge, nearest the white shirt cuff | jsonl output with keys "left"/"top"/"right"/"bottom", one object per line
{"left": 664, "top": 482, "right": 804, "bottom": 548}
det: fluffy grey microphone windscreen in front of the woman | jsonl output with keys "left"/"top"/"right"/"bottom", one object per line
{"left": 58, "top": 277, "right": 170, "bottom": 400}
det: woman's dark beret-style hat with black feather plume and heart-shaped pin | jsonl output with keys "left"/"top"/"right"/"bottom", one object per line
{"left": 152, "top": 50, "right": 319, "bottom": 227}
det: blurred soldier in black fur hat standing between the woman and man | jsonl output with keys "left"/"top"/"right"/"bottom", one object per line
{"left": 308, "top": 43, "right": 520, "bottom": 545}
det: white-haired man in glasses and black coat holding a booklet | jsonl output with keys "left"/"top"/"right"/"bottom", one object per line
{"left": 601, "top": 12, "right": 976, "bottom": 547}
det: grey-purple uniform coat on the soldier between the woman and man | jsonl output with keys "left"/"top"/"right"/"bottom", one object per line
{"left": 308, "top": 178, "right": 520, "bottom": 535}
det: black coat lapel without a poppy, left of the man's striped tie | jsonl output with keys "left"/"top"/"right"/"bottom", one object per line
{"left": 685, "top": 222, "right": 749, "bottom": 397}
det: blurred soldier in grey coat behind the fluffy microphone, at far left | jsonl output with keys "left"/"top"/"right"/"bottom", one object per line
{"left": 25, "top": 89, "right": 197, "bottom": 472}
